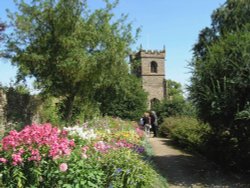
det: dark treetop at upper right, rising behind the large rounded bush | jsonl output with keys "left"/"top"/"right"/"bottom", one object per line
{"left": 191, "top": 0, "right": 250, "bottom": 60}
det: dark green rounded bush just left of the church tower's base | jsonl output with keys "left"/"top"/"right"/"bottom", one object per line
{"left": 95, "top": 74, "right": 147, "bottom": 120}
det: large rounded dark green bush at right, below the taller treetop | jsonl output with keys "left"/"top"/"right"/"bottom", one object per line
{"left": 190, "top": 32, "right": 250, "bottom": 127}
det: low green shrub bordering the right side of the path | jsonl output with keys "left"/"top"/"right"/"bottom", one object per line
{"left": 160, "top": 116, "right": 211, "bottom": 152}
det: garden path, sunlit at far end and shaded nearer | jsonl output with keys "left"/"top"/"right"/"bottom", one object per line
{"left": 149, "top": 138, "right": 250, "bottom": 188}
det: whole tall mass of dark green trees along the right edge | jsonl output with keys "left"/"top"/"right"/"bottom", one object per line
{"left": 189, "top": 0, "right": 250, "bottom": 169}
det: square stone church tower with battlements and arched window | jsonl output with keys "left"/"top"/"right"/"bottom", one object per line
{"left": 130, "top": 48, "right": 166, "bottom": 108}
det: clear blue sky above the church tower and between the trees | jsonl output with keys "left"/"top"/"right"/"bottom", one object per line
{"left": 0, "top": 0, "right": 226, "bottom": 91}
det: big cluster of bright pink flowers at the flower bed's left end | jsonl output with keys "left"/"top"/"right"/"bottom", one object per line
{"left": 0, "top": 123, "right": 75, "bottom": 165}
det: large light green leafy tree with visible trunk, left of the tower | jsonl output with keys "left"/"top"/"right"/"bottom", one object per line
{"left": 5, "top": 0, "right": 138, "bottom": 120}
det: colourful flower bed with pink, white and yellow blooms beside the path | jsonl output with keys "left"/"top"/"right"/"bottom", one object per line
{"left": 0, "top": 118, "right": 166, "bottom": 188}
